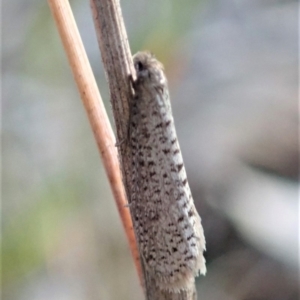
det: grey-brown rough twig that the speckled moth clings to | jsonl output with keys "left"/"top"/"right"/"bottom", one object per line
{"left": 90, "top": 0, "right": 197, "bottom": 300}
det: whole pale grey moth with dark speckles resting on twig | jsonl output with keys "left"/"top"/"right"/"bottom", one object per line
{"left": 129, "top": 52, "right": 206, "bottom": 291}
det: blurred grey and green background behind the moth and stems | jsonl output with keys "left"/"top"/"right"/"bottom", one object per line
{"left": 2, "top": 0, "right": 299, "bottom": 300}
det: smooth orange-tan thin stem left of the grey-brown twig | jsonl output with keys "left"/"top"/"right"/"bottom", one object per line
{"left": 48, "top": 0, "right": 142, "bottom": 281}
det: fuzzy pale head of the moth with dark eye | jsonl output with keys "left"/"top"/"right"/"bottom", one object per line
{"left": 133, "top": 51, "right": 166, "bottom": 86}
